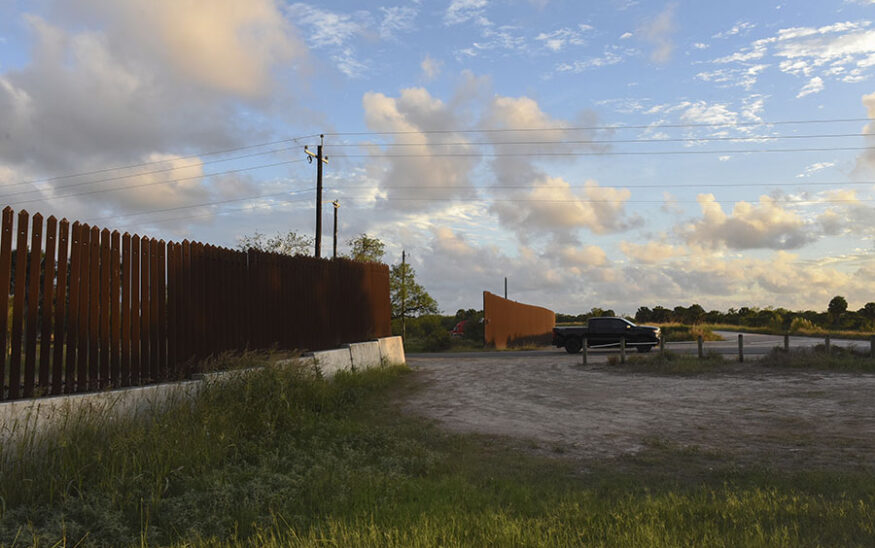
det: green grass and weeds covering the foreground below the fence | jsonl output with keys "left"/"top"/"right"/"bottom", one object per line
{"left": 0, "top": 356, "right": 875, "bottom": 547}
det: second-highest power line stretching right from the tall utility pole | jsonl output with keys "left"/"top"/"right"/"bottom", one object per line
{"left": 326, "top": 133, "right": 875, "bottom": 148}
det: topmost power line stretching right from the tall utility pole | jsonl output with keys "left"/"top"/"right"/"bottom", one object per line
{"left": 325, "top": 118, "right": 872, "bottom": 137}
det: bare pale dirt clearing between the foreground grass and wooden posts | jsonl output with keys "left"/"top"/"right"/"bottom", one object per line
{"left": 405, "top": 351, "right": 875, "bottom": 466}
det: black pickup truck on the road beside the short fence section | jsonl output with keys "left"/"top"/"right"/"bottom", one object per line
{"left": 553, "top": 318, "right": 660, "bottom": 354}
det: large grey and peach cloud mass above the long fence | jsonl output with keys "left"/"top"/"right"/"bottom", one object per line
{"left": 0, "top": 0, "right": 306, "bottom": 218}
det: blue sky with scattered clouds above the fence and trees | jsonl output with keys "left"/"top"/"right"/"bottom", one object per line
{"left": 0, "top": 0, "right": 875, "bottom": 313}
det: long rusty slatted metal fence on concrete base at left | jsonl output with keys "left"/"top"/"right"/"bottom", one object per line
{"left": 0, "top": 207, "right": 391, "bottom": 401}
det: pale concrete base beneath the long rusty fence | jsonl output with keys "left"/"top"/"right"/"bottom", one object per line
{"left": 0, "top": 337, "right": 406, "bottom": 444}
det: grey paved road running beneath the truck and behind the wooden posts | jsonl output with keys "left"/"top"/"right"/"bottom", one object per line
{"left": 410, "top": 331, "right": 869, "bottom": 362}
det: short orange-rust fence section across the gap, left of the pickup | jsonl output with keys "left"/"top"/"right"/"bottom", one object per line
{"left": 483, "top": 291, "right": 556, "bottom": 348}
